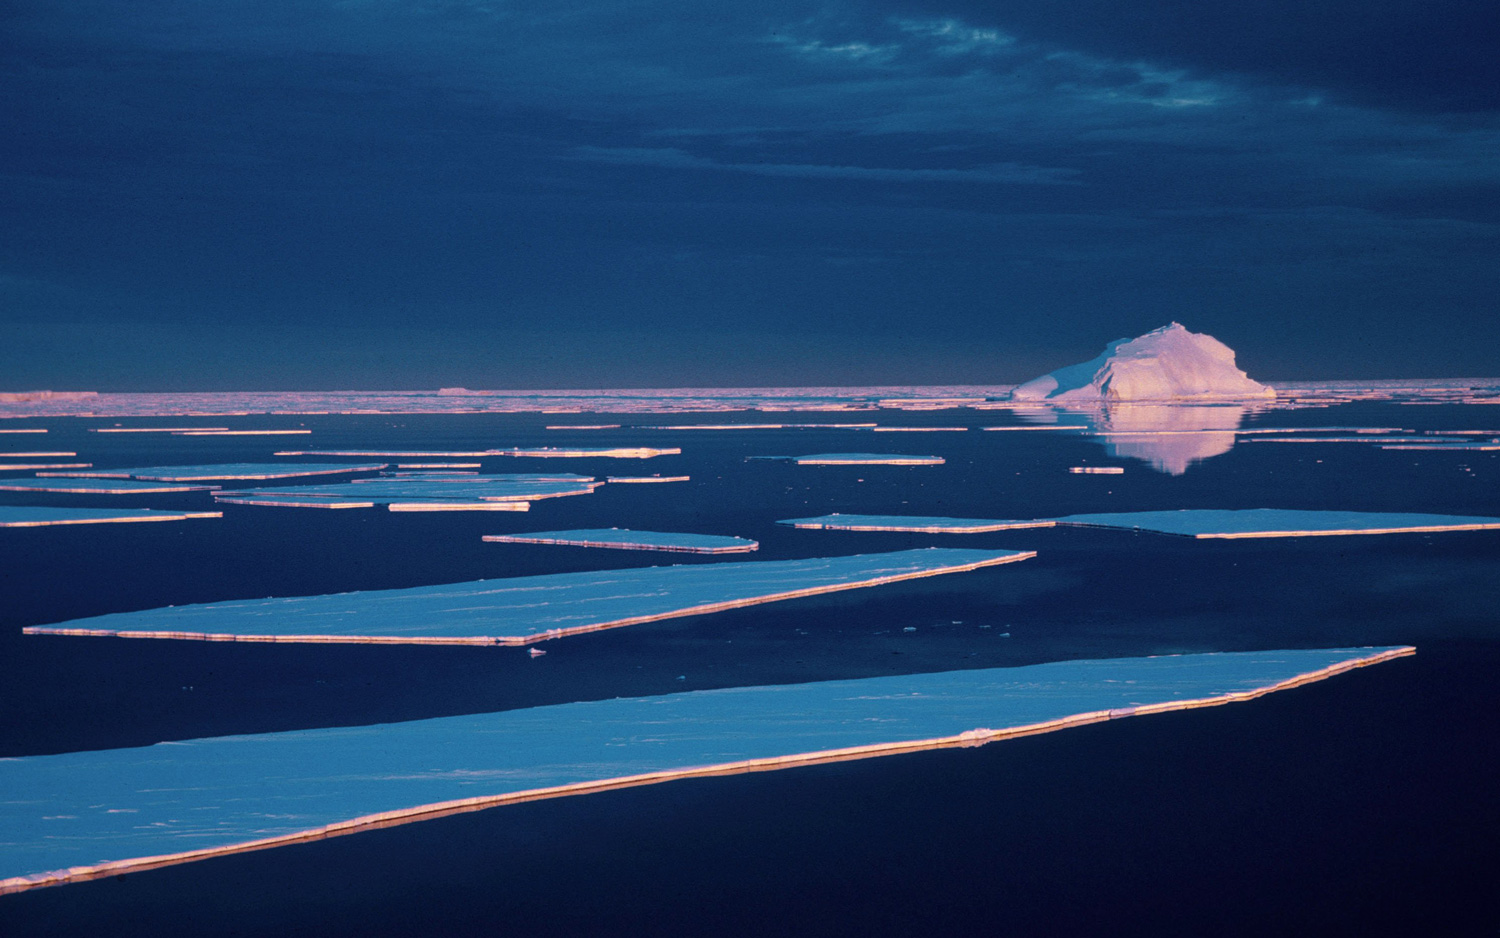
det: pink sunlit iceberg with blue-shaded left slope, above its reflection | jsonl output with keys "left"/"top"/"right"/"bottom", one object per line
{"left": 1011, "top": 323, "right": 1277, "bottom": 402}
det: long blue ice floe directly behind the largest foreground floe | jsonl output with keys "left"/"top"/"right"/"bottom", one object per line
{"left": 24, "top": 548, "right": 1037, "bottom": 645}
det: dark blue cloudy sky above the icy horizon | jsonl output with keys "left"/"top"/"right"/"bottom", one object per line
{"left": 0, "top": 0, "right": 1500, "bottom": 390}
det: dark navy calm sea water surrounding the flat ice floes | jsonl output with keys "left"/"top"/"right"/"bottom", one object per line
{"left": 0, "top": 404, "right": 1500, "bottom": 935}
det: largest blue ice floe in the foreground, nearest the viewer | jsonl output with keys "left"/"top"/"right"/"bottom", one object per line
{"left": 0, "top": 647, "right": 1413, "bottom": 893}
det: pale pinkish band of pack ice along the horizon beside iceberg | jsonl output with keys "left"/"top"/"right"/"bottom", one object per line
{"left": 0, "top": 377, "right": 1500, "bottom": 419}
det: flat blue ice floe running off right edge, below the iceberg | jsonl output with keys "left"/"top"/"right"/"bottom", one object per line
{"left": 1053, "top": 509, "right": 1500, "bottom": 537}
